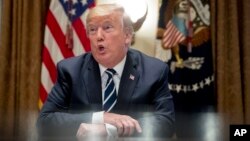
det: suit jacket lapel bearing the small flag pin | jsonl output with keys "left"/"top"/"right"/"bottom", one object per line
{"left": 114, "top": 52, "right": 139, "bottom": 110}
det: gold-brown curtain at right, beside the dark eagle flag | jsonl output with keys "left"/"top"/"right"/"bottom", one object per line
{"left": 211, "top": 0, "right": 250, "bottom": 137}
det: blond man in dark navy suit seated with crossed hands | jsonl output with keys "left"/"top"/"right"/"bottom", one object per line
{"left": 37, "top": 4, "right": 174, "bottom": 139}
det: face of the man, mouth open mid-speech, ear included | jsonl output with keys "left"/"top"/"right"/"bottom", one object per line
{"left": 87, "top": 12, "right": 132, "bottom": 68}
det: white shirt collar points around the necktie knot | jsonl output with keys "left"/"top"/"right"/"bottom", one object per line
{"left": 98, "top": 55, "right": 127, "bottom": 77}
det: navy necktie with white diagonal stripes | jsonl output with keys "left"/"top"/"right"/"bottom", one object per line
{"left": 103, "top": 69, "right": 117, "bottom": 112}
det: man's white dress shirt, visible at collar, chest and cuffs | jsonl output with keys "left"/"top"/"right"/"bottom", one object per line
{"left": 92, "top": 56, "right": 127, "bottom": 137}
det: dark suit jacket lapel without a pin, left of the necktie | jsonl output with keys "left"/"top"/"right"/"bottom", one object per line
{"left": 83, "top": 56, "right": 102, "bottom": 108}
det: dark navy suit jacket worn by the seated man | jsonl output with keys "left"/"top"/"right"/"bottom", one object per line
{"left": 37, "top": 49, "right": 174, "bottom": 137}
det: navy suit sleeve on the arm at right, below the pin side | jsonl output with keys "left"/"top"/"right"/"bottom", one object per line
{"left": 139, "top": 65, "right": 175, "bottom": 137}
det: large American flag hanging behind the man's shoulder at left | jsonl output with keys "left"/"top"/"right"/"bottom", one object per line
{"left": 39, "top": 0, "right": 95, "bottom": 108}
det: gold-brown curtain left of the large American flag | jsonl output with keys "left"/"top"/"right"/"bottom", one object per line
{"left": 0, "top": 0, "right": 49, "bottom": 140}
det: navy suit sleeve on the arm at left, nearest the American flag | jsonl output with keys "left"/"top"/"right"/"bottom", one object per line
{"left": 37, "top": 63, "right": 92, "bottom": 136}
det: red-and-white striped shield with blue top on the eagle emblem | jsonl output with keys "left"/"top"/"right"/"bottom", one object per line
{"left": 162, "top": 16, "right": 188, "bottom": 48}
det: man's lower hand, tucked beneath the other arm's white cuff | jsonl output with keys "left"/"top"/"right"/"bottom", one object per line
{"left": 76, "top": 123, "right": 107, "bottom": 140}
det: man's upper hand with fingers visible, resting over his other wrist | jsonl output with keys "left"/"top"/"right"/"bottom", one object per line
{"left": 103, "top": 112, "right": 142, "bottom": 136}
